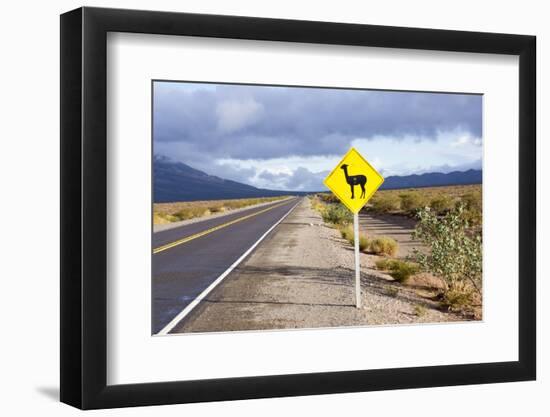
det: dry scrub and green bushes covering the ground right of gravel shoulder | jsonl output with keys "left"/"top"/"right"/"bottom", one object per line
{"left": 312, "top": 185, "right": 483, "bottom": 319}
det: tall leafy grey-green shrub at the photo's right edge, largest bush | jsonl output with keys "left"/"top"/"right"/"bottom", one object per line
{"left": 413, "top": 205, "right": 482, "bottom": 294}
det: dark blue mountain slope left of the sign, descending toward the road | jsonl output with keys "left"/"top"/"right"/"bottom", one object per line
{"left": 153, "top": 156, "right": 305, "bottom": 203}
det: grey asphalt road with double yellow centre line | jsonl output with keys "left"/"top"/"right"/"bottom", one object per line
{"left": 152, "top": 198, "right": 299, "bottom": 334}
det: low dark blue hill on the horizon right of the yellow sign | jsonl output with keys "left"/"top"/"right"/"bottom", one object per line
{"left": 380, "top": 169, "right": 482, "bottom": 190}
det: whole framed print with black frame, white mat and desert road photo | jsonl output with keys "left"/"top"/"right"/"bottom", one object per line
{"left": 61, "top": 8, "right": 536, "bottom": 409}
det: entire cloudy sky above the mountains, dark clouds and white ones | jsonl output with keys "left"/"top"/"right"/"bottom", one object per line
{"left": 153, "top": 82, "right": 482, "bottom": 191}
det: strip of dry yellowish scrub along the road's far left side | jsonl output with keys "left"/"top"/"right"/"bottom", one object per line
{"left": 153, "top": 196, "right": 287, "bottom": 224}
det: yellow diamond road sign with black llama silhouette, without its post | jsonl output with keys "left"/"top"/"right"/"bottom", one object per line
{"left": 323, "top": 148, "right": 384, "bottom": 213}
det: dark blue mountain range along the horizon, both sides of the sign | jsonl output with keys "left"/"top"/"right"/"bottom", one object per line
{"left": 153, "top": 156, "right": 482, "bottom": 203}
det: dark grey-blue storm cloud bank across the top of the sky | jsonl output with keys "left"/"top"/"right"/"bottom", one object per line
{"left": 153, "top": 82, "right": 481, "bottom": 159}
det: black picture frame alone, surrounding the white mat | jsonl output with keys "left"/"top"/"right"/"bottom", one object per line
{"left": 60, "top": 7, "right": 536, "bottom": 409}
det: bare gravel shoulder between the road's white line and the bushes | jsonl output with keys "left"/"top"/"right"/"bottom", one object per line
{"left": 175, "top": 198, "right": 465, "bottom": 332}
